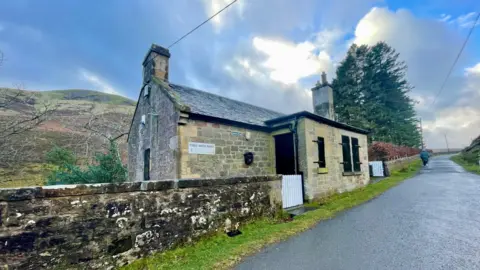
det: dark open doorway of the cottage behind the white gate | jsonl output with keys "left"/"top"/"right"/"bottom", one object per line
{"left": 274, "top": 133, "right": 295, "bottom": 175}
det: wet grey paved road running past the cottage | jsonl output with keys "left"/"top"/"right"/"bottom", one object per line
{"left": 237, "top": 156, "right": 480, "bottom": 270}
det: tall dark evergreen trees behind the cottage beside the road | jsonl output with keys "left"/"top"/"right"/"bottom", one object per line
{"left": 332, "top": 42, "right": 421, "bottom": 147}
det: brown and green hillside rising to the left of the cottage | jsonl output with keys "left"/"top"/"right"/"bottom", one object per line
{"left": 0, "top": 88, "right": 136, "bottom": 187}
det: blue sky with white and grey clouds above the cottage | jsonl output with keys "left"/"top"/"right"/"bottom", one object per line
{"left": 0, "top": 0, "right": 480, "bottom": 148}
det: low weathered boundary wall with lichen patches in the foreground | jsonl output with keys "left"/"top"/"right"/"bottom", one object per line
{"left": 0, "top": 175, "right": 281, "bottom": 269}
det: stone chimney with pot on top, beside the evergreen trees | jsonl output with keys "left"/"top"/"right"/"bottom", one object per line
{"left": 312, "top": 72, "right": 335, "bottom": 120}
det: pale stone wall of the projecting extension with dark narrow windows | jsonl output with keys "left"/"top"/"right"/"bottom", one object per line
{"left": 298, "top": 118, "right": 370, "bottom": 199}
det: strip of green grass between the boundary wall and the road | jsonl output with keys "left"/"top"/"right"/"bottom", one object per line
{"left": 122, "top": 160, "right": 421, "bottom": 270}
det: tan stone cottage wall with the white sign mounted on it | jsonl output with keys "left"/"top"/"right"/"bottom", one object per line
{"left": 178, "top": 119, "right": 275, "bottom": 178}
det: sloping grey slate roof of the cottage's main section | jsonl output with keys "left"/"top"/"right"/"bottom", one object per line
{"left": 169, "top": 83, "right": 284, "bottom": 127}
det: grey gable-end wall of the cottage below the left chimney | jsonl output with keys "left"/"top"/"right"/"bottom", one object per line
{"left": 128, "top": 80, "right": 180, "bottom": 181}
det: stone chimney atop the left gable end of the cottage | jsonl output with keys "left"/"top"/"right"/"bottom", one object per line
{"left": 143, "top": 44, "right": 170, "bottom": 83}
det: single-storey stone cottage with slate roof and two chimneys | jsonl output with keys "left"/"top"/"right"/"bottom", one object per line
{"left": 128, "top": 45, "right": 369, "bottom": 199}
